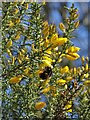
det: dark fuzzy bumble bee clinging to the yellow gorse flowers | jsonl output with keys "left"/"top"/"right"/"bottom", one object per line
{"left": 39, "top": 66, "right": 52, "bottom": 80}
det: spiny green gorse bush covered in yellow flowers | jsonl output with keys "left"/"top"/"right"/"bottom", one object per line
{"left": 2, "top": 2, "right": 90, "bottom": 120}
